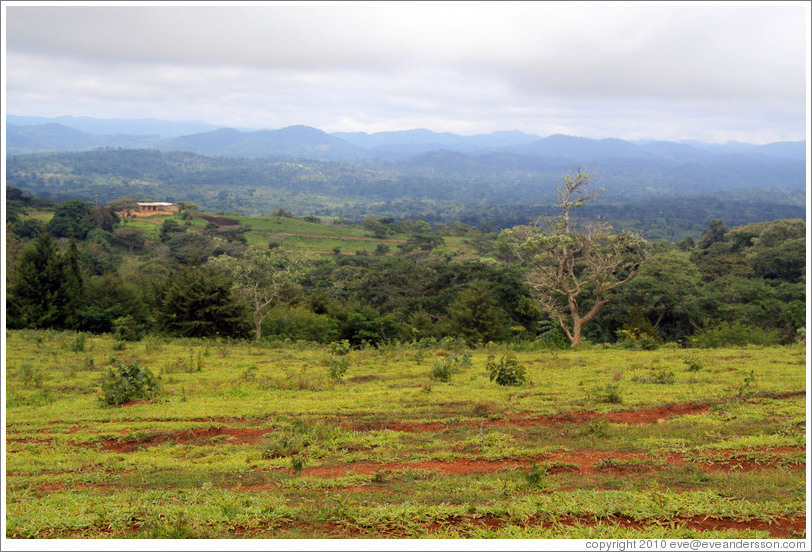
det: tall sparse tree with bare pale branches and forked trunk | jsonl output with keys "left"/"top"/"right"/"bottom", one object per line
{"left": 501, "top": 170, "right": 646, "bottom": 347}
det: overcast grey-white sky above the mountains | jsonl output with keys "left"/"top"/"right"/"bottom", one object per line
{"left": 3, "top": 2, "right": 810, "bottom": 143}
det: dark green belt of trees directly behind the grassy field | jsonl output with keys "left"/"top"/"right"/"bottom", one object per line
{"left": 6, "top": 183, "right": 806, "bottom": 348}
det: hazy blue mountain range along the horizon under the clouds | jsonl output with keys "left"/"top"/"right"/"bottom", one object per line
{"left": 6, "top": 115, "right": 806, "bottom": 164}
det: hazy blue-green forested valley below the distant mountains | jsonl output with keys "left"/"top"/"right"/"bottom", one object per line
{"left": 7, "top": 149, "right": 805, "bottom": 241}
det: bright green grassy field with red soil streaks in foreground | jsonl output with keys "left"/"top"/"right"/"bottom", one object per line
{"left": 6, "top": 331, "right": 806, "bottom": 539}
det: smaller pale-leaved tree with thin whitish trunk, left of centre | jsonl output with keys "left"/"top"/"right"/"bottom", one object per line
{"left": 208, "top": 247, "right": 310, "bottom": 341}
